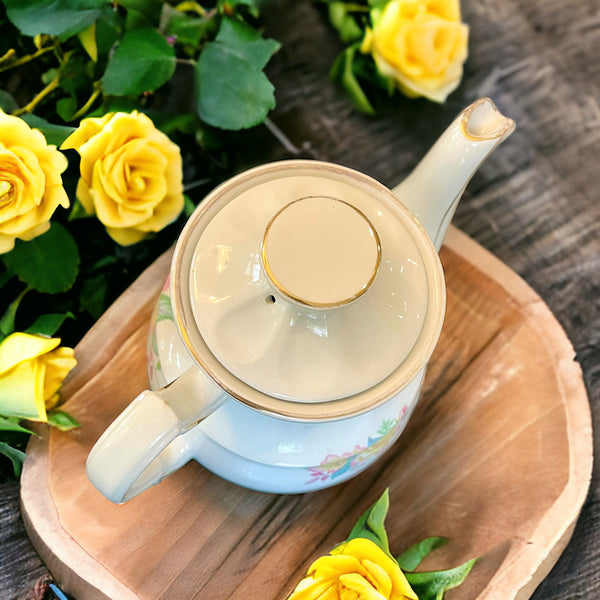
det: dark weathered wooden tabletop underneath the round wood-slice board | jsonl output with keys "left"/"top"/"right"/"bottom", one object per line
{"left": 0, "top": 0, "right": 600, "bottom": 600}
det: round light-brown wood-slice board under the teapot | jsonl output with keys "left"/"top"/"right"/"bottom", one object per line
{"left": 21, "top": 229, "right": 592, "bottom": 600}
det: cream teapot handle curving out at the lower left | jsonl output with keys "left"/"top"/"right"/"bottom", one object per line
{"left": 86, "top": 366, "right": 229, "bottom": 504}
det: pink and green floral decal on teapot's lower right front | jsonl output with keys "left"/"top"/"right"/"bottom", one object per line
{"left": 305, "top": 406, "right": 408, "bottom": 485}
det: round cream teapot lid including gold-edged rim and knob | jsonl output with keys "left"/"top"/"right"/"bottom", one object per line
{"left": 171, "top": 160, "right": 445, "bottom": 419}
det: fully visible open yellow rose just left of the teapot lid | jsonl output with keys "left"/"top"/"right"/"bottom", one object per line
{"left": 61, "top": 111, "right": 183, "bottom": 246}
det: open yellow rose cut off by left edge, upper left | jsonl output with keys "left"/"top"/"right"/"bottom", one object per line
{"left": 0, "top": 110, "right": 69, "bottom": 254}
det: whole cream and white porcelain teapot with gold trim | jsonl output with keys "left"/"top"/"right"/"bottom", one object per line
{"left": 86, "top": 98, "right": 514, "bottom": 503}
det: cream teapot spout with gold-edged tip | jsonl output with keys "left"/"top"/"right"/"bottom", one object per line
{"left": 392, "top": 98, "right": 515, "bottom": 250}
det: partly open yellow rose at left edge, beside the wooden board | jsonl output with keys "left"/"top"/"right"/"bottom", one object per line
{"left": 0, "top": 332, "right": 77, "bottom": 422}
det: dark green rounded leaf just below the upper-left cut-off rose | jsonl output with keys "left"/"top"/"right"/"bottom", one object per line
{"left": 4, "top": 223, "right": 79, "bottom": 294}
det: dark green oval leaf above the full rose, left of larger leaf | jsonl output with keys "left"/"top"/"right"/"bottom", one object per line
{"left": 102, "top": 29, "right": 175, "bottom": 96}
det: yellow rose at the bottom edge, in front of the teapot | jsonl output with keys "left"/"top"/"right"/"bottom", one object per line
{"left": 288, "top": 538, "right": 418, "bottom": 600}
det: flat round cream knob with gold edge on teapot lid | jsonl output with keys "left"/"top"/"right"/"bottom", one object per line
{"left": 261, "top": 196, "right": 381, "bottom": 308}
